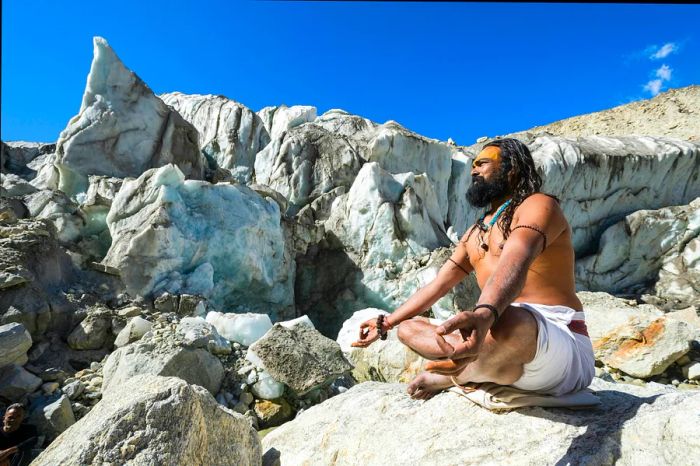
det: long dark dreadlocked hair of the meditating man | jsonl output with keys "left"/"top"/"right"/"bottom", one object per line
{"left": 482, "top": 138, "right": 556, "bottom": 239}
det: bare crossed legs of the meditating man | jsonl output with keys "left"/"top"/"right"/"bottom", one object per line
{"left": 398, "top": 306, "right": 537, "bottom": 399}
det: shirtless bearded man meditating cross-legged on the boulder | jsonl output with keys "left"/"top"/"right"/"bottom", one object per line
{"left": 353, "top": 139, "right": 594, "bottom": 399}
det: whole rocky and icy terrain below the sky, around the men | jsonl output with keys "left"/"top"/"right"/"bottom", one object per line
{"left": 0, "top": 38, "right": 700, "bottom": 464}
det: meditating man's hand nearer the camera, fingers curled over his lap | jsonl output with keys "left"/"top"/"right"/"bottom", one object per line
{"left": 426, "top": 308, "right": 493, "bottom": 375}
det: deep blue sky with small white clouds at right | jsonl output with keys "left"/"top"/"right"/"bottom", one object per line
{"left": 2, "top": 0, "right": 700, "bottom": 145}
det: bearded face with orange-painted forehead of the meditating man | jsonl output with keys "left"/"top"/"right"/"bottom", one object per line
{"left": 467, "top": 146, "right": 510, "bottom": 207}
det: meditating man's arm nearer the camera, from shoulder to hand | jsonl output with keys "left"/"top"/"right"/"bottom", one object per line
{"left": 436, "top": 194, "right": 567, "bottom": 360}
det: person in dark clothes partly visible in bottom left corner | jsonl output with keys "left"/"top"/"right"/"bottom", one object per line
{"left": 0, "top": 403, "right": 37, "bottom": 466}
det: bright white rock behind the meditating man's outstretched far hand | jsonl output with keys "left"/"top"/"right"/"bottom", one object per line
{"left": 336, "top": 308, "right": 427, "bottom": 383}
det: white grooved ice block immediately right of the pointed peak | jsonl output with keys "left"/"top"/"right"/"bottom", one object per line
{"left": 160, "top": 92, "right": 270, "bottom": 183}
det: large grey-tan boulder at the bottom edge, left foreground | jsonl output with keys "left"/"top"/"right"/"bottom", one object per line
{"left": 34, "top": 376, "right": 261, "bottom": 465}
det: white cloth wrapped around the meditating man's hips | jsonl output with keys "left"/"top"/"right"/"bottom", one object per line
{"left": 512, "top": 303, "right": 595, "bottom": 396}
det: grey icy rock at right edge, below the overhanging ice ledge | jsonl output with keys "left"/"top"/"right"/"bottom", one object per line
{"left": 576, "top": 198, "right": 700, "bottom": 296}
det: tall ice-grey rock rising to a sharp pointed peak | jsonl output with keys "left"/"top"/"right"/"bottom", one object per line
{"left": 56, "top": 37, "right": 206, "bottom": 195}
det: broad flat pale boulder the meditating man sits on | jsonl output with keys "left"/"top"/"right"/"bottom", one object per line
{"left": 263, "top": 379, "right": 700, "bottom": 466}
